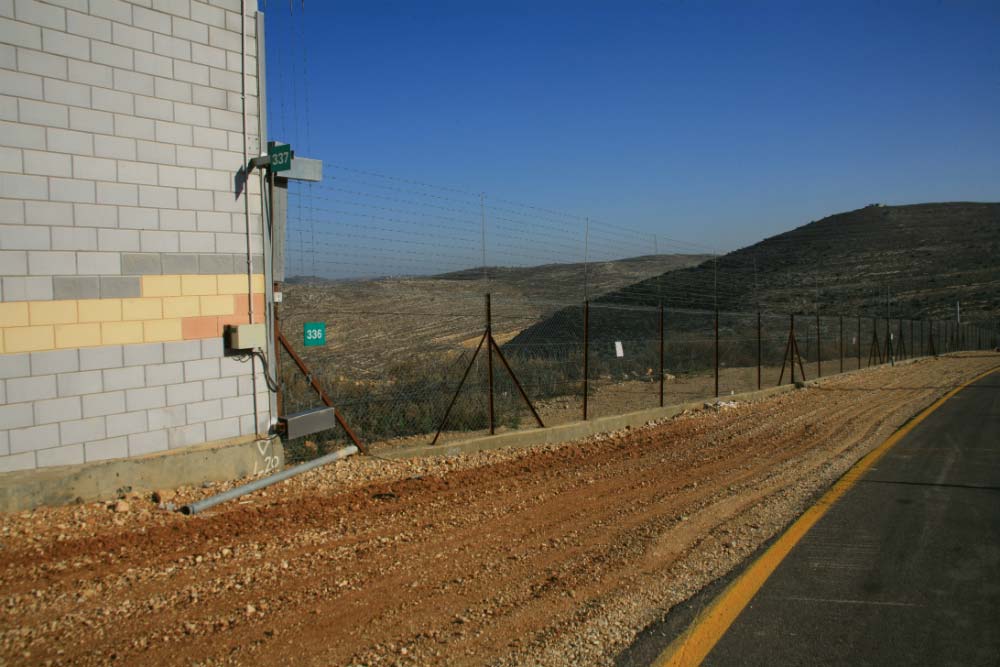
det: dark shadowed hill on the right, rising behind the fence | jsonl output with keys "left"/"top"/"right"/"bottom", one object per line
{"left": 512, "top": 202, "right": 1000, "bottom": 345}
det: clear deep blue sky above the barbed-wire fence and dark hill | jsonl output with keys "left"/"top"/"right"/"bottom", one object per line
{"left": 262, "top": 0, "right": 1000, "bottom": 250}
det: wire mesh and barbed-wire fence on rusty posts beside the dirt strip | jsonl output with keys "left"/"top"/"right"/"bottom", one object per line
{"left": 279, "top": 164, "right": 984, "bottom": 461}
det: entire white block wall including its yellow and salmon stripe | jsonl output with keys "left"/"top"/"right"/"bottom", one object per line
{"left": 0, "top": 0, "right": 270, "bottom": 472}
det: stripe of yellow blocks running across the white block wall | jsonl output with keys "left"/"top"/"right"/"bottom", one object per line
{"left": 0, "top": 274, "right": 264, "bottom": 354}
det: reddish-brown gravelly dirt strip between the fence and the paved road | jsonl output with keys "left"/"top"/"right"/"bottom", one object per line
{"left": 0, "top": 353, "right": 1000, "bottom": 665}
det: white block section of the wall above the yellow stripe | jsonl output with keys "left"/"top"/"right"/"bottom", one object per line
{"left": 0, "top": 0, "right": 262, "bottom": 277}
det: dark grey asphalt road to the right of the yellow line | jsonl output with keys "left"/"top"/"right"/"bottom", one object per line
{"left": 619, "top": 372, "right": 1000, "bottom": 665}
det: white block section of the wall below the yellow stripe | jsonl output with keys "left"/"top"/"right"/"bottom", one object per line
{"left": 0, "top": 339, "right": 267, "bottom": 472}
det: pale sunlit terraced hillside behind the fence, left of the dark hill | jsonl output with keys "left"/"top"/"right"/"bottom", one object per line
{"left": 282, "top": 254, "right": 707, "bottom": 379}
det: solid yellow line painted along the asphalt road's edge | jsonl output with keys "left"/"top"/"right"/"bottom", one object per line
{"left": 653, "top": 368, "right": 1000, "bottom": 667}
